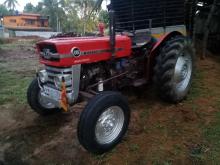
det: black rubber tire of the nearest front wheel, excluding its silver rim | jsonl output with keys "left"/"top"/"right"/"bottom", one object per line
{"left": 77, "top": 92, "right": 130, "bottom": 154}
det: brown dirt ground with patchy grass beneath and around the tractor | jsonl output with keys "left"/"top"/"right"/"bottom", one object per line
{"left": 0, "top": 41, "right": 220, "bottom": 165}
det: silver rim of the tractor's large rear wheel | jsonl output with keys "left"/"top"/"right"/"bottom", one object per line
{"left": 174, "top": 52, "right": 192, "bottom": 92}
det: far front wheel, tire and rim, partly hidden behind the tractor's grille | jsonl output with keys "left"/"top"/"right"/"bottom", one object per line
{"left": 27, "top": 78, "right": 60, "bottom": 115}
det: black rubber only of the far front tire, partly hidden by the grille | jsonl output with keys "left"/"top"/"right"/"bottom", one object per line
{"left": 27, "top": 78, "right": 61, "bottom": 116}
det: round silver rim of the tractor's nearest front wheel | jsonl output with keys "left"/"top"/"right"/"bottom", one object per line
{"left": 95, "top": 106, "right": 125, "bottom": 144}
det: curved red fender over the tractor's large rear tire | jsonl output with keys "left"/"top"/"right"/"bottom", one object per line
{"left": 147, "top": 31, "right": 183, "bottom": 81}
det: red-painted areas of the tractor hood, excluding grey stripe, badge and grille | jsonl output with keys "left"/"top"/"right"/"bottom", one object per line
{"left": 37, "top": 35, "right": 131, "bottom": 67}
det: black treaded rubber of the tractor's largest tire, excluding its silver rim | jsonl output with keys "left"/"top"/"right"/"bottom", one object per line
{"left": 154, "top": 36, "right": 195, "bottom": 103}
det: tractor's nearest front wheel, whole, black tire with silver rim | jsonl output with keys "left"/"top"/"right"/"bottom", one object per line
{"left": 78, "top": 92, "right": 130, "bottom": 154}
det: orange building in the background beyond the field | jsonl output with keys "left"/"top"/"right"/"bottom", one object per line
{"left": 3, "top": 13, "right": 51, "bottom": 31}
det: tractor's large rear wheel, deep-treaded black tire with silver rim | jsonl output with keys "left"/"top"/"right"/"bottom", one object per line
{"left": 154, "top": 36, "right": 195, "bottom": 103}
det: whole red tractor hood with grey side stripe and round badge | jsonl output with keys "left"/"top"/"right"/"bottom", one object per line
{"left": 37, "top": 35, "right": 131, "bottom": 67}
